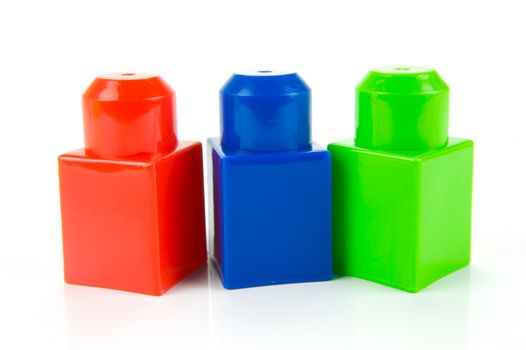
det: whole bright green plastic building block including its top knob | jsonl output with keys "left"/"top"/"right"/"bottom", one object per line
{"left": 328, "top": 67, "right": 473, "bottom": 292}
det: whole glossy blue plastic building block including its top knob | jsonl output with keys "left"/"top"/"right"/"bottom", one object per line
{"left": 208, "top": 72, "right": 332, "bottom": 289}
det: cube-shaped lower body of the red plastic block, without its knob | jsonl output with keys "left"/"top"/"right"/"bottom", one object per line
{"left": 59, "top": 141, "right": 207, "bottom": 295}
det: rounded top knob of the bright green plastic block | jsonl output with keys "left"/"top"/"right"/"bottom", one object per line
{"left": 356, "top": 67, "right": 449, "bottom": 151}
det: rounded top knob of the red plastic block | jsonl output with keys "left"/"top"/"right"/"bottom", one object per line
{"left": 82, "top": 73, "right": 177, "bottom": 158}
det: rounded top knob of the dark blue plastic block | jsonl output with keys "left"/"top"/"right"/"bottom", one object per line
{"left": 221, "top": 71, "right": 311, "bottom": 152}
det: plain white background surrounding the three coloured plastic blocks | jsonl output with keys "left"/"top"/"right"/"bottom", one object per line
{"left": 0, "top": 0, "right": 526, "bottom": 349}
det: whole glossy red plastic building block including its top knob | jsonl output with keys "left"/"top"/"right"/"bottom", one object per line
{"left": 59, "top": 74, "right": 207, "bottom": 295}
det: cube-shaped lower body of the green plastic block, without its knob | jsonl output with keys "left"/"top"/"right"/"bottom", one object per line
{"left": 328, "top": 138, "right": 473, "bottom": 292}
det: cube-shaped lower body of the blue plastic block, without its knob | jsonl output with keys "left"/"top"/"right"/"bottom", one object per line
{"left": 208, "top": 139, "right": 332, "bottom": 289}
